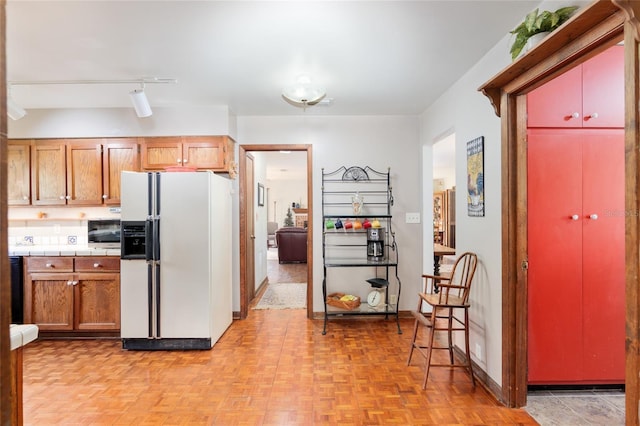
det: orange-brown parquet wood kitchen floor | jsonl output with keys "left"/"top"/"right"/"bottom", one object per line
{"left": 24, "top": 309, "right": 537, "bottom": 425}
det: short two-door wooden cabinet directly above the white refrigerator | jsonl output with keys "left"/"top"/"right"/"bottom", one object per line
{"left": 141, "top": 136, "right": 233, "bottom": 172}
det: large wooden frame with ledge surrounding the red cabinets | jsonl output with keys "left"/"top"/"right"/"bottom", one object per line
{"left": 479, "top": 0, "right": 640, "bottom": 424}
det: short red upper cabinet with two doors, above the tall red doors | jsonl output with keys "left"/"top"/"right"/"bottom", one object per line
{"left": 527, "top": 46, "right": 624, "bottom": 128}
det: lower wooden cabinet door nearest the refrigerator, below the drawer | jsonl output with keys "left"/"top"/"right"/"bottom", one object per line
{"left": 74, "top": 273, "right": 120, "bottom": 331}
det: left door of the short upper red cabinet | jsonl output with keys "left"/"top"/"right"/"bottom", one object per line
{"left": 527, "top": 66, "right": 582, "bottom": 127}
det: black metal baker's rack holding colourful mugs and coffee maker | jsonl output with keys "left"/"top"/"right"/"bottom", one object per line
{"left": 322, "top": 166, "right": 402, "bottom": 334}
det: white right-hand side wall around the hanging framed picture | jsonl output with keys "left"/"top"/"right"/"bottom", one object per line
{"left": 421, "top": 32, "right": 510, "bottom": 384}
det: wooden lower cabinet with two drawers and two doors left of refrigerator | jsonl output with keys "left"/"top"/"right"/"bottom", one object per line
{"left": 24, "top": 256, "right": 120, "bottom": 336}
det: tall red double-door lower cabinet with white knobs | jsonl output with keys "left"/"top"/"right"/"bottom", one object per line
{"left": 527, "top": 129, "right": 625, "bottom": 384}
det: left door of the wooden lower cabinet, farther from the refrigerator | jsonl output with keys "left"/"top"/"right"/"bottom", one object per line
{"left": 24, "top": 273, "right": 74, "bottom": 331}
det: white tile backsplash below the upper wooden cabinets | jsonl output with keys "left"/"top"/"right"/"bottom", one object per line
{"left": 8, "top": 207, "right": 120, "bottom": 246}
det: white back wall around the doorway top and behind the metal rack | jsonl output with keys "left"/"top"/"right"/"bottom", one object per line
{"left": 238, "top": 115, "right": 422, "bottom": 312}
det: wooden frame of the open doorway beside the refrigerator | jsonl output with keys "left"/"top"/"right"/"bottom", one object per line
{"left": 238, "top": 144, "right": 313, "bottom": 319}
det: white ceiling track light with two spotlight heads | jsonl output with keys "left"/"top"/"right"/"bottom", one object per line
{"left": 7, "top": 77, "right": 178, "bottom": 120}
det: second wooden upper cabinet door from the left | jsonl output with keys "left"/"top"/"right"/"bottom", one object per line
{"left": 31, "top": 140, "right": 67, "bottom": 205}
